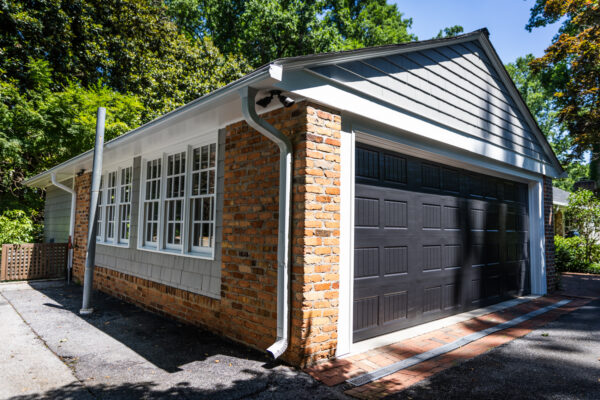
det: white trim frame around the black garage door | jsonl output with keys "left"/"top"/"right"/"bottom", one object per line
{"left": 336, "top": 115, "right": 546, "bottom": 357}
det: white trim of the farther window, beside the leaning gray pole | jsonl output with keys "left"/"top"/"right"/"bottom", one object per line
{"left": 96, "top": 163, "right": 133, "bottom": 247}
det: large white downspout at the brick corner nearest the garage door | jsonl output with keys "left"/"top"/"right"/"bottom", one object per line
{"left": 240, "top": 87, "right": 292, "bottom": 359}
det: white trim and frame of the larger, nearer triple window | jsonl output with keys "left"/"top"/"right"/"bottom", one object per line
{"left": 137, "top": 132, "right": 219, "bottom": 260}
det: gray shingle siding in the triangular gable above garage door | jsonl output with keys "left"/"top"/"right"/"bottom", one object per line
{"left": 311, "top": 42, "right": 549, "bottom": 163}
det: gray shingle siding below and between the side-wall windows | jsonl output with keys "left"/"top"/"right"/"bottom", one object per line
{"left": 96, "top": 130, "right": 225, "bottom": 298}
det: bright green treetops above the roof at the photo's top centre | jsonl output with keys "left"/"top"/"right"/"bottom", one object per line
{"left": 166, "top": 0, "right": 416, "bottom": 67}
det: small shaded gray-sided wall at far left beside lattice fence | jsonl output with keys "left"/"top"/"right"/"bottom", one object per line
{"left": 44, "top": 179, "right": 73, "bottom": 243}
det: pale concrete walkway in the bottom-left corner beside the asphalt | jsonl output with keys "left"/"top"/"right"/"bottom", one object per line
{"left": 0, "top": 284, "right": 92, "bottom": 399}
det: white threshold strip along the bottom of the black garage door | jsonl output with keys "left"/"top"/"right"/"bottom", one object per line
{"left": 342, "top": 295, "right": 539, "bottom": 358}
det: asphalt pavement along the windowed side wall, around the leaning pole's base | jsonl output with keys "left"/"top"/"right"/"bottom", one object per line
{"left": 0, "top": 283, "right": 344, "bottom": 400}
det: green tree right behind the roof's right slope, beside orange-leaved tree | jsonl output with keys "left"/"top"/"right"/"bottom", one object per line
{"left": 506, "top": 54, "right": 588, "bottom": 191}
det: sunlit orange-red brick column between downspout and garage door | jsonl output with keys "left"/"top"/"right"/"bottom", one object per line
{"left": 289, "top": 105, "right": 341, "bottom": 365}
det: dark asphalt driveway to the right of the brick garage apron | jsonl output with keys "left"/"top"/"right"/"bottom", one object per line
{"left": 389, "top": 274, "right": 600, "bottom": 400}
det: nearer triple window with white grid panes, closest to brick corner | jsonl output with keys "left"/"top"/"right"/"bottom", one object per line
{"left": 139, "top": 143, "right": 217, "bottom": 256}
